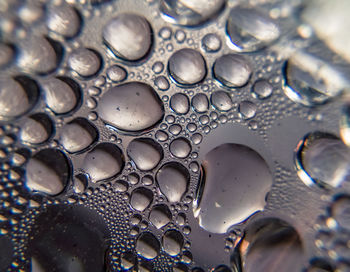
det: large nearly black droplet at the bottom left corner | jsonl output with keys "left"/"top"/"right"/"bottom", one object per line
{"left": 28, "top": 205, "right": 110, "bottom": 272}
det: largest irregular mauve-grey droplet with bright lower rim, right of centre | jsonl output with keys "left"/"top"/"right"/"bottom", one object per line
{"left": 193, "top": 144, "right": 273, "bottom": 233}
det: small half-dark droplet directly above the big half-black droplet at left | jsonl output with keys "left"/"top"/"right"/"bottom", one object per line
{"left": 19, "top": 113, "right": 53, "bottom": 144}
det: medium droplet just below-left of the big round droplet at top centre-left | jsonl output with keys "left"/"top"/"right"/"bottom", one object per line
{"left": 68, "top": 48, "right": 101, "bottom": 77}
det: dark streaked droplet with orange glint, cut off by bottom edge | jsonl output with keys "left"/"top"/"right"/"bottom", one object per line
{"left": 231, "top": 218, "right": 304, "bottom": 272}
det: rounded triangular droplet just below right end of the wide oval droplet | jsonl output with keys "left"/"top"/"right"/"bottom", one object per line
{"left": 127, "top": 138, "right": 163, "bottom": 171}
